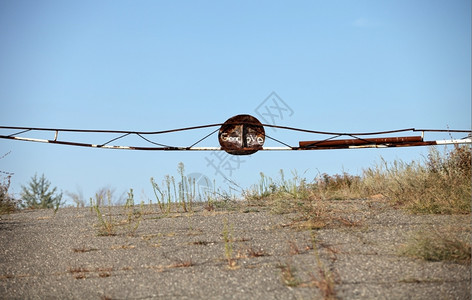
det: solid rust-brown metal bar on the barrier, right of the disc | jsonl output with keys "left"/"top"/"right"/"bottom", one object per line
{"left": 299, "top": 136, "right": 423, "bottom": 149}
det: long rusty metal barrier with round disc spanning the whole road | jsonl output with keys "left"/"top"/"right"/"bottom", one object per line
{"left": 0, "top": 115, "right": 472, "bottom": 155}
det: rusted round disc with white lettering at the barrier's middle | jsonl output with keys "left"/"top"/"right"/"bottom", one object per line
{"left": 218, "top": 115, "right": 265, "bottom": 155}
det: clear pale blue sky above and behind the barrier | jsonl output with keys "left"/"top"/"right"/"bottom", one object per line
{"left": 0, "top": 0, "right": 471, "bottom": 201}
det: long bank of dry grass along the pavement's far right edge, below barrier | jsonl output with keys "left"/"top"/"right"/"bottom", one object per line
{"left": 245, "top": 145, "right": 472, "bottom": 217}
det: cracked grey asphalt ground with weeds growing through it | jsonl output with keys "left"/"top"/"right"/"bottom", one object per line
{"left": 0, "top": 200, "right": 471, "bottom": 299}
